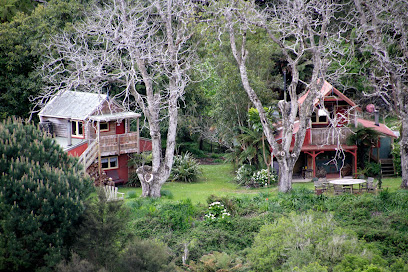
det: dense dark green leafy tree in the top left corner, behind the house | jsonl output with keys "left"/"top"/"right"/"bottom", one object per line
{"left": 0, "top": 0, "right": 87, "bottom": 119}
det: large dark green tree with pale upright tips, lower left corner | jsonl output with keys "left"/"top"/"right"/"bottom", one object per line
{"left": 0, "top": 120, "right": 92, "bottom": 271}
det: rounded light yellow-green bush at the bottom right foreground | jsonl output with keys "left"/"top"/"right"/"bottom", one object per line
{"left": 248, "top": 212, "right": 380, "bottom": 271}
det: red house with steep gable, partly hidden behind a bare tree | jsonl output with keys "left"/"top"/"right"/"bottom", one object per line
{"left": 277, "top": 81, "right": 396, "bottom": 178}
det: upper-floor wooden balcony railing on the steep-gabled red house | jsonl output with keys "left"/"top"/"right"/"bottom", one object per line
{"left": 310, "top": 127, "right": 353, "bottom": 145}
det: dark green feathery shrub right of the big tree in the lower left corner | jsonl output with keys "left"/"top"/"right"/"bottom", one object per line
{"left": 74, "top": 189, "right": 130, "bottom": 270}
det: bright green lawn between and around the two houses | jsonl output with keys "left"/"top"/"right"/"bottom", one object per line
{"left": 119, "top": 164, "right": 401, "bottom": 204}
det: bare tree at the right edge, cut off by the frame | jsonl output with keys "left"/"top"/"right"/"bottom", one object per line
{"left": 354, "top": 0, "right": 408, "bottom": 189}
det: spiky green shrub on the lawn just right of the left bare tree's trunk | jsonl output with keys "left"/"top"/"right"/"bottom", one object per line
{"left": 170, "top": 152, "right": 201, "bottom": 182}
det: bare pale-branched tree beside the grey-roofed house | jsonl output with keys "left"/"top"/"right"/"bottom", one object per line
{"left": 39, "top": 0, "right": 195, "bottom": 197}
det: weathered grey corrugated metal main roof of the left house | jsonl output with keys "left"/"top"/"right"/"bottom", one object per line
{"left": 39, "top": 91, "right": 107, "bottom": 120}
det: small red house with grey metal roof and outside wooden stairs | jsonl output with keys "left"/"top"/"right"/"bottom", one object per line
{"left": 39, "top": 91, "right": 152, "bottom": 183}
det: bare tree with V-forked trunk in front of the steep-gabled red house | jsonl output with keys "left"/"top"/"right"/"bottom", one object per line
{"left": 215, "top": 0, "right": 347, "bottom": 192}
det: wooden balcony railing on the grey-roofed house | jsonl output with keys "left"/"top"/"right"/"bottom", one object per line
{"left": 100, "top": 132, "right": 140, "bottom": 156}
